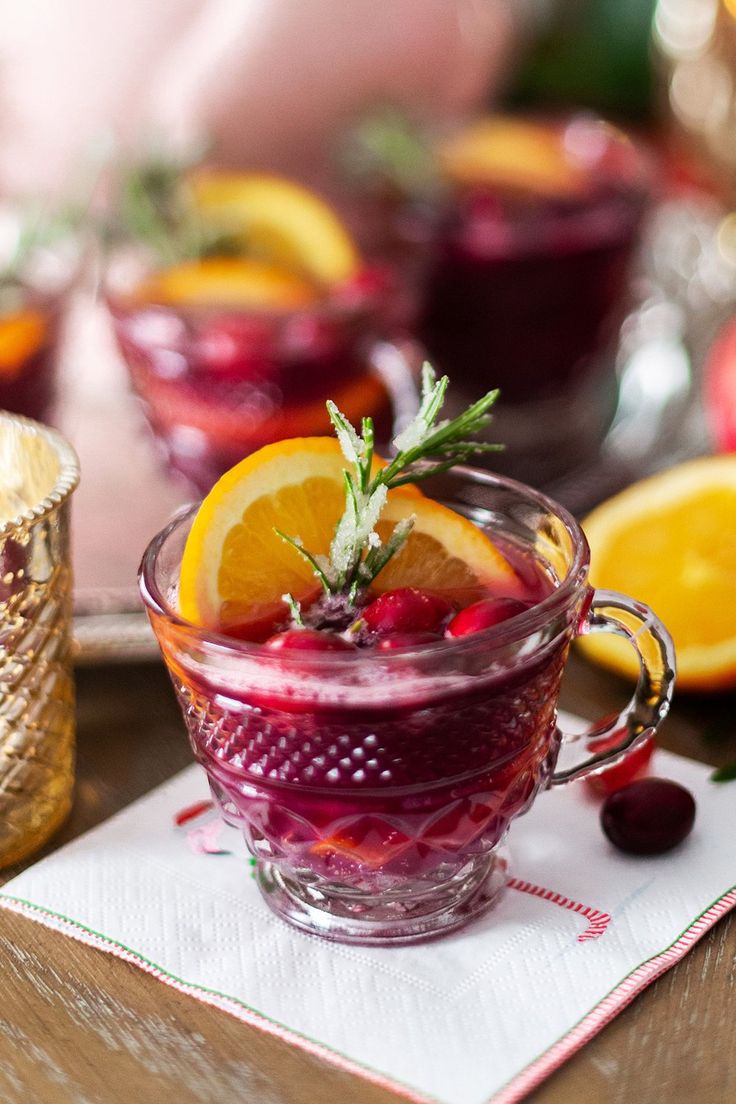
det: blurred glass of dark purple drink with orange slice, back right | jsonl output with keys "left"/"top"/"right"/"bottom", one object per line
{"left": 418, "top": 116, "right": 647, "bottom": 482}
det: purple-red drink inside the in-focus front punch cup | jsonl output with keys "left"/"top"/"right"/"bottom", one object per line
{"left": 169, "top": 538, "right": 568, "bottom": 892}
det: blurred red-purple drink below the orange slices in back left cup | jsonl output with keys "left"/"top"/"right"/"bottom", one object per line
{"left": 108, "top": 289, "right": 392, "bottom": 491}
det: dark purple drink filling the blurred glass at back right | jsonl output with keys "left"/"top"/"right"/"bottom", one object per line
{"left": 418, "top": 184, "right": 641, "bottom": 403}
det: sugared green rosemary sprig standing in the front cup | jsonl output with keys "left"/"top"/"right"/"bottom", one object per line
{"left": 276, "top": 363, "right": 501, "bottom": 605}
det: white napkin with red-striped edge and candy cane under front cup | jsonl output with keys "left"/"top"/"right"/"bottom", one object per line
{"left": 0, "top": 724, "right": 736, "bottom": 1104}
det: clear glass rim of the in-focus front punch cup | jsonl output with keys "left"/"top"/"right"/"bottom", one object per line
{"left": 138, "top": 466, "right": 590, "bottom": 671}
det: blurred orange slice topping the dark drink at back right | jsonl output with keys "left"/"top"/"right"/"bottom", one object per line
{"left": 439, "top": 115, "right": 588, "bottom": 198}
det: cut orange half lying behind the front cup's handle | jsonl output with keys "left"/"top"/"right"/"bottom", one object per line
{"left": 580, "top": 455, "right": 736, "bottom": 690}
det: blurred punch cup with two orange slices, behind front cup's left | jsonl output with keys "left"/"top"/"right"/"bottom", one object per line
{"left": 106, "top": 170, "right": 415, "bottom": 492}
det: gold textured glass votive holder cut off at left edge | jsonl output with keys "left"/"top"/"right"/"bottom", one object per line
{"left": 0, "top": 412, "right": 79, "bottom": 867}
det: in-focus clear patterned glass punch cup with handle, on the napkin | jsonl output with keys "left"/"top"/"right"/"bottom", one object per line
{"left": 141, "top": 457, "right": 674, "bottom": 944}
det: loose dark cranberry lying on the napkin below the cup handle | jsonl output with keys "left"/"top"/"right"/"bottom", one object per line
{"left": 600, "top": 778, "right": 695, "bottom": 854}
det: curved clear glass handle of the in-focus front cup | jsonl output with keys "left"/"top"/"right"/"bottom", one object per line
{"left": 550, "top": 590, "right": 675, "bottom": 786}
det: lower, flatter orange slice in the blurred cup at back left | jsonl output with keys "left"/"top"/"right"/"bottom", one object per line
{"left": 136, "top": 257, "right": 318, "bottom": 310}
